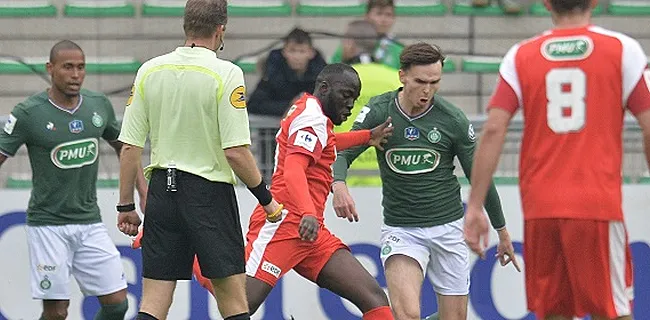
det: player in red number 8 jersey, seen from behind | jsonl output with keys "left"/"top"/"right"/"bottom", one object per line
{"left": 465, "top": 0, "right": 650, "bottom": 319}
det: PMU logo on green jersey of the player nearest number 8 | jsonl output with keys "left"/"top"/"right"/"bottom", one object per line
{"left": 386, "top": 148, "right": 440, "bottom": 174}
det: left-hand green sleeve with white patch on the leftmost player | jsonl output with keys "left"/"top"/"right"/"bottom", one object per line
{"left": 0, "top": 105, "right": 30, "bottom": 157}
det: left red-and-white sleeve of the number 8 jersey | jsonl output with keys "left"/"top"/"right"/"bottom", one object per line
{"left": 488, "top": 44, "right": 522, "bottom": 113}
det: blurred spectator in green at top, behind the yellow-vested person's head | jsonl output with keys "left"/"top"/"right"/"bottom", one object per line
{"left": 331, "top": 0, "right": 404, "bottom": 69}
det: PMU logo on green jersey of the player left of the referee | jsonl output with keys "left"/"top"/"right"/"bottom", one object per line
{"left": 50, "top": 138, "right": 99, "bottom": 169}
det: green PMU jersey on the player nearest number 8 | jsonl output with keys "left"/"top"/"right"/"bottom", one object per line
{"left": 334, "top": 89, "right": 505, "bottom": 228}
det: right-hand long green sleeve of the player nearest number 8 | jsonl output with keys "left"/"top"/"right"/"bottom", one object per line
{"left": 454, "top": 111, "right": 506, "bottom": 230}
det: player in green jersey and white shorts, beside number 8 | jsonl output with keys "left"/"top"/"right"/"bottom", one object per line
{"left": 332, "top": 43, "right": 514, "bottom": 320}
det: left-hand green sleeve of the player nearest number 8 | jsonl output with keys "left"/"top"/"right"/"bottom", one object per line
{"left": 332, "top": 104, "right": 385, "bottom": 181}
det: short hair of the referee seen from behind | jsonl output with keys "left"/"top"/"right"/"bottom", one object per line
{"left": 183, "top": 0, "right": 228, "bottom": 38}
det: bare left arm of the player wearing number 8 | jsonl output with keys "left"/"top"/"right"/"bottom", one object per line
{"left": 465, "top": 108, "right": 512, "bottom": 258}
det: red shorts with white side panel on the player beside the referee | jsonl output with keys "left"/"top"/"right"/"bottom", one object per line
{"left": 246, "top": 206, "right": 350, "bottom": 286}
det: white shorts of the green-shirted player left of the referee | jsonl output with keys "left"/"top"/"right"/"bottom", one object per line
{"left": 27, "top": 223, "right": 126, "bottom": 300}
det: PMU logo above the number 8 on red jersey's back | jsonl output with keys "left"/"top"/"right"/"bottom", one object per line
{"left": 541, "top": 36, "right": 594, "bottom": 61}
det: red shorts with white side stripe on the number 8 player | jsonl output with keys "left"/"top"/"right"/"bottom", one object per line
{"left": 524, "top": 219, "right": 632, "bottom": 319}
